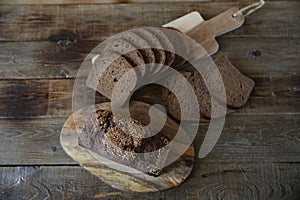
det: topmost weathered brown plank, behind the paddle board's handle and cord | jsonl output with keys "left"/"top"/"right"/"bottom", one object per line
{"left": 0, "top": 1, "right": 300, "bottom": 41}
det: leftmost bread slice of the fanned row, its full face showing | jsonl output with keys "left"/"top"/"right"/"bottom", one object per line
{"left": 86, "top": 52, "right": 136, "bottom": 99}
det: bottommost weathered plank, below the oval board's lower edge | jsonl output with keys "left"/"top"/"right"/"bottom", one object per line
{"left": 0, "top": 163, "right": 300, "bottom": 200}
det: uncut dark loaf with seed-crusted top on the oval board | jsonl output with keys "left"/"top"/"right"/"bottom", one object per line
{"left": 78, "top": 110, "right": 170, "bottom": 176}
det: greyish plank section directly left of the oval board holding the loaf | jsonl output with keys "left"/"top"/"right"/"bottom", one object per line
{"left": 0, "top": 118, "right": 74, "bottom": 165}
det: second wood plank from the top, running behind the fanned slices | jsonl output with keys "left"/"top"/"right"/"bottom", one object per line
{"left": 0, "top": 37, "right": 300, "bottom": 79}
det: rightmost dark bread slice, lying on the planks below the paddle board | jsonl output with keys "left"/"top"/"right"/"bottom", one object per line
{"left": 204, "top": 54, "right": 255, "bottom": 108}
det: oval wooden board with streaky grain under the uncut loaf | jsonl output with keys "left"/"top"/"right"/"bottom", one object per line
{"left": 60, "top": 102, "right": 195, "bottom": 192}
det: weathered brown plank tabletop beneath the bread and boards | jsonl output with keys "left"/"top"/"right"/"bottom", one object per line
{"left": 0, "top": 0, "right": 300, "bottom": 200}
